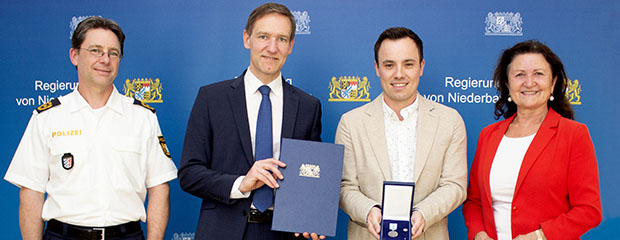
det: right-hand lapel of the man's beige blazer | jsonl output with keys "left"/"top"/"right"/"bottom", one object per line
{"left": 413, "top": 94, "right": 439, "bottom": 182}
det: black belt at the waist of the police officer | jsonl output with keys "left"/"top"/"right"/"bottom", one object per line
{"left": 47, "top": 219, "right": 142, "bottom": 240}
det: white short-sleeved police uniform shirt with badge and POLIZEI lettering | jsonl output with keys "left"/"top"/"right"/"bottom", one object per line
{"left": 4, "top": 88, "right": 177, "bottom": 227}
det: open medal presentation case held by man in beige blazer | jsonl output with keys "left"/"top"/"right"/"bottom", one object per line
{"left": 381, "top": 181, "right": 415, "bottom": 240}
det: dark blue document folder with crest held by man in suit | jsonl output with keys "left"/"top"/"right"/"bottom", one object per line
{"left": 271, "top": 138, "right": 344, "bottom": 236}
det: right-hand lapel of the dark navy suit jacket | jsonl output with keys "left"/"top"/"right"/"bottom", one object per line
{"left": 281, "top": 79, "right": 299, "bottom": 138}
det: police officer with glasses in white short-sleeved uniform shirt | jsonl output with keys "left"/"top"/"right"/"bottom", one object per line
{"left": 4, "top": 17, "right": 177, "bottom": 240}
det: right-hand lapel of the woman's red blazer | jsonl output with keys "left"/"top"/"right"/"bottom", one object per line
{"left": 515, "top": 108, "right": 560, "bottom": 195}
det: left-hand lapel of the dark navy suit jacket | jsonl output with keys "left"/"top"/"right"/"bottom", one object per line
{"left": 228, "top": 72, "right": 254, "bottom": 166}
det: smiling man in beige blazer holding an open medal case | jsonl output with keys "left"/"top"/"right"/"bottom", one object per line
{"left": 336, "top": 27, "right": 467, "bottom": 240}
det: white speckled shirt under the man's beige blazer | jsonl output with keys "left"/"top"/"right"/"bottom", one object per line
{"left": 383, "top": 96, "right": 418, "bottom": 182}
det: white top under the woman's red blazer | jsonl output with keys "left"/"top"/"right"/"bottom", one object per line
{"left": 489, "top": 135, "right": 534, "bottom": 240}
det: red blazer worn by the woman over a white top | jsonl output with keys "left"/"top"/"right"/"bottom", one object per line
{"left": 463, "top": 109, "right": 602, "bottom": 240}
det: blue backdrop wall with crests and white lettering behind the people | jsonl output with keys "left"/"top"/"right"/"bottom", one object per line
{"left": 0, "top": 0, "right": 620, "bottom": 240}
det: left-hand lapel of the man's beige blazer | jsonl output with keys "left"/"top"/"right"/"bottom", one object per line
{"left": 363, "top": 94, "right": 392, "bottom": 180}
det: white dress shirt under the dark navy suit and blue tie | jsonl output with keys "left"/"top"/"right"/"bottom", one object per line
{"left": 230, "top": 68, "right": 284, "bottom": 199}
